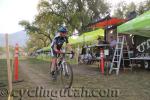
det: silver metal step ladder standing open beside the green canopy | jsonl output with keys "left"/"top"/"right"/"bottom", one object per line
{"left": 109, "top": 36, "right": 131, "bottom": 75}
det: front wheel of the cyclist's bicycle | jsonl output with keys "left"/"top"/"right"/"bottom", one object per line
{"left": 61, "top": 62, "right": 73, "bottom": 89}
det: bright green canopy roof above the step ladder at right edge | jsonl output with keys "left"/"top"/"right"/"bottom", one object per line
{"left": 117, "top": 11, "right": 150, "bottom": 37}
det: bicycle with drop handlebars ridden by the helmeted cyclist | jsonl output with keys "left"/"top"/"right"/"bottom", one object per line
{"left": 50, "top": 53, "right": 74, "bottom": 89}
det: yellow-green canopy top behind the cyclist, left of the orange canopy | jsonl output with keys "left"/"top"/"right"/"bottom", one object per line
{"left": 69, "top": 29, "right": 104, "bottom": 45}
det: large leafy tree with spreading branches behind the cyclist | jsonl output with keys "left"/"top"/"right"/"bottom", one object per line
{"left": 19, "top": 0, "right": 109, "bottom": 51}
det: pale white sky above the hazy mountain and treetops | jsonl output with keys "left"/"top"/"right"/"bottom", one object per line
{"left": 0, "top": 0, "right": 145, "bottom": 34}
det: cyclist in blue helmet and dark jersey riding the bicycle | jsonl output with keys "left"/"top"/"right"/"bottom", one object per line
{"left": 51, "top": 27, "right": 73, "bottom": 80}
